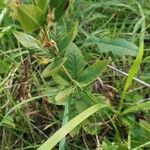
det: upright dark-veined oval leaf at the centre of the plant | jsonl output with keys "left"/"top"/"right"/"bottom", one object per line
{"left": 64, "top": 43, "right": 85, "bottom": 79}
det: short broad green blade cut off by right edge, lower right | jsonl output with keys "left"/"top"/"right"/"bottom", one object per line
{"left": 121, "top": 101, "right": 150, "bottom": 115}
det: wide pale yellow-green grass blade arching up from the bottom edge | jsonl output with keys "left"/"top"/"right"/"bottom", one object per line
{"left": 37, "top": 104, "right": 107, "bottom": 150}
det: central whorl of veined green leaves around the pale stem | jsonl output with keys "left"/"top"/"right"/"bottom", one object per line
{"left": 42, "top": 43, "right": 109, "bottom": 104}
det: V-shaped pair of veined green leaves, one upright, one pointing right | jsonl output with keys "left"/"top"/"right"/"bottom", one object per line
{"left": 64, "top": 43, "right": 110, "bottom": 86}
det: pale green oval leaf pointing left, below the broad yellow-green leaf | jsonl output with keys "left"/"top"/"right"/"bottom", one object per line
{"left": 14, "top": 31, "right": 42, "bottom": 48}
